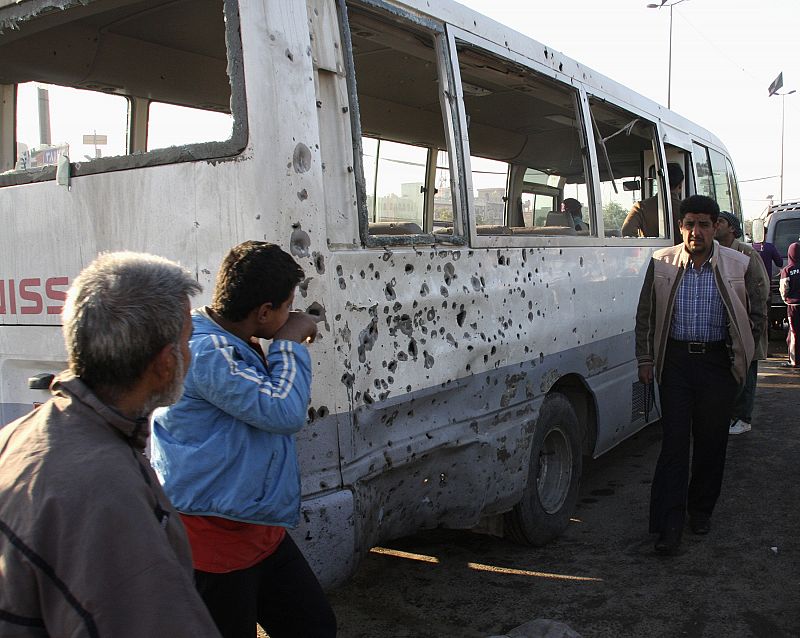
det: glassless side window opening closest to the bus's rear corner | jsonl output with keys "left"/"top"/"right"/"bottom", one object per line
{"left": 347, "top": 3, "right": 454, "bottom": 243}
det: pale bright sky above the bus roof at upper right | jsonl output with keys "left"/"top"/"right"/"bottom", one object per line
{"left": 458, "top": 0, "right": 800, "bottom": 218}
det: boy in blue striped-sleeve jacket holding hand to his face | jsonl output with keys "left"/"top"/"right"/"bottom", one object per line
{"left": 151, "top": 241, "right": 336, "bottom": 638}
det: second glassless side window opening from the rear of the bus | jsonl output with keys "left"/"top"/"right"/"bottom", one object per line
{"left": 456, "top": 40, "right": 597, "bottom": 236}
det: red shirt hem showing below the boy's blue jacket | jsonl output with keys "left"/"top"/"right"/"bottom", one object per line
{"left": 181, "top": 514, "right": 286, "bottom": 574}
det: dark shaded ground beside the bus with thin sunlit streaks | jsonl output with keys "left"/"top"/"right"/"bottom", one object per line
{"left": 329, "top": 341, "right": 800, "bottom": 638}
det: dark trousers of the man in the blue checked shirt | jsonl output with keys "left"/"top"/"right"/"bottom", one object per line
{"left": 650, "top": 342, "right": 739, "bottom": 533}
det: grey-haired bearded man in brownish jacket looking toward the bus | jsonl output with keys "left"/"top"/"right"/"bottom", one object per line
{"left": 0, "top": 252, "right": 219, "bottom": 638}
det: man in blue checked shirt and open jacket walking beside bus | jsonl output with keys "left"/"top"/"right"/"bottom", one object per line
{"left": 636, "top": 195, "right": 764, "bottom": 555}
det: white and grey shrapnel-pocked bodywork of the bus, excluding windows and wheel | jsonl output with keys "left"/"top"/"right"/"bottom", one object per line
{"left": 0, "top": 0, "right": 736, "bottom": 584}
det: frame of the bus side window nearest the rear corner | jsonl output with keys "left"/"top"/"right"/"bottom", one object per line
{"left": 337, "top": 0, "right": 466, "bottom": 248}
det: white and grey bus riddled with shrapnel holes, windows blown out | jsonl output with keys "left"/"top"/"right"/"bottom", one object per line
{"left": 0, "top": 0, "right": 741, "bottom": 584}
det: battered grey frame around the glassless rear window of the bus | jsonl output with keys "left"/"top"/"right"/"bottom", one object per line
{"left": 0, "top": 0, "right": 249, "bottom": 188}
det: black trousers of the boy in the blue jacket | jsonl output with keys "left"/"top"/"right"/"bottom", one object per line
{"left": 195, "top": 534, "right": 336, "bottom": 638}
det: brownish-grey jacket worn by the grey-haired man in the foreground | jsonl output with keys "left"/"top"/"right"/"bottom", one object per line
{"left": 0, "top": 373, "right": 219, "bottom": 638}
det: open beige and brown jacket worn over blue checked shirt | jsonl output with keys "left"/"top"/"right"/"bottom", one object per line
{"left": 636, "top": 241, "right": 765, "bottom": 385}
